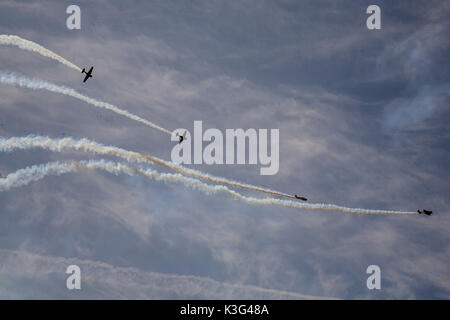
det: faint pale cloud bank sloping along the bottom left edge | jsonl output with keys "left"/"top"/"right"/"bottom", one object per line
{"left": 0, "top": 249, "right": 333, "bottom": 300}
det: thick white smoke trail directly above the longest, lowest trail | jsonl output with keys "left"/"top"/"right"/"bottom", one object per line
{"left": 0, "top": 136, "right": 295, "bottom": 199}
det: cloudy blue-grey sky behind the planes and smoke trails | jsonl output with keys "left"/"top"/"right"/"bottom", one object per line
{"left": 0, "top": 0, "right": 450, "bottom": 299}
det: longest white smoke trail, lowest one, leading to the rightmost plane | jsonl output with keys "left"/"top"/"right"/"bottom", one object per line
{"left": 0, "top": 159, "right": 417, "bottom": 215}
